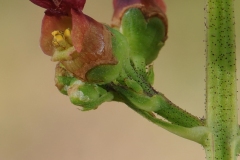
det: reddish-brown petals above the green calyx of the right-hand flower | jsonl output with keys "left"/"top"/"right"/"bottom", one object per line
{"left": 112, "top": 0, "right": 167, "bottom": 37}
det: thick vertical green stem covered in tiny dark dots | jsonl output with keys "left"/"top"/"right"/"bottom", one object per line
{"left": 205, "top": 0, "right": 238, "bottom": 160}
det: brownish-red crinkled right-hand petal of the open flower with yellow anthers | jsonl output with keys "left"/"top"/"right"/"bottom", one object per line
{"left": 61, "top": 10, "right": 117, "bottom": 80}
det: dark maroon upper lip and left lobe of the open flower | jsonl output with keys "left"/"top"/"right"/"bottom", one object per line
{"left": 30, "top": 0, "right": 86, "bottom": 56}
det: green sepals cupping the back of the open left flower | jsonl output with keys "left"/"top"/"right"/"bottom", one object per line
{"left": 86, "top": 27, "right": 129, "bottom": 84}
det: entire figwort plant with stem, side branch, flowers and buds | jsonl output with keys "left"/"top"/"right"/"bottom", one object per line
{"left": 30, "top": 0, "right": 240, "bottom": 160}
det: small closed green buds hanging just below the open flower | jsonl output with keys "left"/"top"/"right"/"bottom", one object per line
{"left": 55, "top": 63, "right": 113, "bottom": 111}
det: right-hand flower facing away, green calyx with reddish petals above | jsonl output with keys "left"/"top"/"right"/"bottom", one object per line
{"left": 112, "top": 0, "right": 168, "bottom": 66}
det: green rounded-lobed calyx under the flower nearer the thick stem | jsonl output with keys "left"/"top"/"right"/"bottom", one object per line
{"left": 121, "top": 8, "right": 165, "bottom": 65}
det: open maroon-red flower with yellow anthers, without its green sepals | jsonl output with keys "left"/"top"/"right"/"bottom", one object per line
{"left": 31, "top": 0, "right": 117, "bottom": 81}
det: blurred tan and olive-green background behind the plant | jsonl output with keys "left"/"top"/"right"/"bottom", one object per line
{"left": 0, "top": 0, "right": 240, "bottom": 160}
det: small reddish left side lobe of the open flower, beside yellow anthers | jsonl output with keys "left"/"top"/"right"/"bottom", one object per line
{"left": 40, "top": 15, "right": 72, "bottom": 56}
